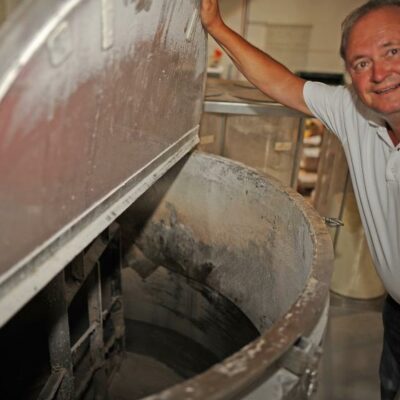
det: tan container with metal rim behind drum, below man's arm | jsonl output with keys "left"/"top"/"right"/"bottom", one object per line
{"left": 199, "top": 79, "right": 305, "bottom": 188}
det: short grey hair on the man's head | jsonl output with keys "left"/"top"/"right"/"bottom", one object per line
{"left": 340, "top": 0, "right": 400, "bottom": 61}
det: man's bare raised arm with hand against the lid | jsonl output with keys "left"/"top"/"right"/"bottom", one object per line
{"left": 201, "top": 0, "right": 311, "bottom": 115}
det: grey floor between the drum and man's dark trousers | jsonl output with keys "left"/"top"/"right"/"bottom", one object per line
{"left": 313, "top": 294, "right": 384, "bottom": 400}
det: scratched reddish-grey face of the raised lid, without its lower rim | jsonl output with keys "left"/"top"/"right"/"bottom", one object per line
{"left": 0, "top": 0, "right": 206, "bottom": 280}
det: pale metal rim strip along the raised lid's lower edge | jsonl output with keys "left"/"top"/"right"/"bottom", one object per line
{"left": 0, "top": 127, "right": 198, "bottom": 328}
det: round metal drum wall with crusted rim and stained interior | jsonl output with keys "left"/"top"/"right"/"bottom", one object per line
{"left": 118, "top": 152, "right": 333, "bottom": 400}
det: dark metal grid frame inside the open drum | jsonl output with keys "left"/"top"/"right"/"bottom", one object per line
{"left": 32, "top": 224, "right": 124, "bottom": 400}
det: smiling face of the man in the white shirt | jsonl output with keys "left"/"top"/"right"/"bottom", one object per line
{"left": 346, "top": 6, "right": 400, "bottom": 117}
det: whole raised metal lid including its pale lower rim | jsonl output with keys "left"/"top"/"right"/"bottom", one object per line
{"left": 0, "top": 0, "right": 206, "bottom": 328}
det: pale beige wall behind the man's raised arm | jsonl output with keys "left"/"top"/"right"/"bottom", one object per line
{"left": 209, "top": 0, "right": 365, "bottom": 78}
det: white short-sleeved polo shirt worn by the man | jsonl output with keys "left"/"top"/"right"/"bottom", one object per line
{"left": 304, "top": 82, "right": 400, "bottom": 303}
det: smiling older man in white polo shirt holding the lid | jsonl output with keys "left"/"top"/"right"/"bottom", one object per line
{"left": 201, "top": 0, "right": 400, "bottom": 400}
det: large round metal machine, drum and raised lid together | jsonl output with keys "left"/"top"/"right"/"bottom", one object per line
{"left": 0, "top": 0, "right": 332, "bottom": 400}
